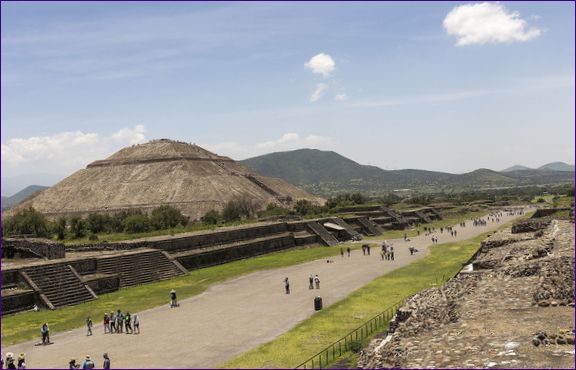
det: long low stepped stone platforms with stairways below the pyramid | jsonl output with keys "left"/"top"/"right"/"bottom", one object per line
{"left": 2, "top": 217, "right": 388, "bottom": 314}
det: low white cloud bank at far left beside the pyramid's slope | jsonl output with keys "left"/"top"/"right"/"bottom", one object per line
{"left": 2, "top": 125, "right": 146, "bottom": 177}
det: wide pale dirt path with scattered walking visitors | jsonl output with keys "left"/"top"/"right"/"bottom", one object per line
{"left": 2, "top": 210, "right": 516, "bottom": 368}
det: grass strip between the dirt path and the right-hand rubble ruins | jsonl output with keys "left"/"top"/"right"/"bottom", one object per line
{"left": 223, "top": 233, "right": 498, "bottom": 368}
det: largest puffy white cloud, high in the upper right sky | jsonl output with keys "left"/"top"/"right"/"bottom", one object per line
{"left": 443, "top": 3, "right": 542, "bottom": 46}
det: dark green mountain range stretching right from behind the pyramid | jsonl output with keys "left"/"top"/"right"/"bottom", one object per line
{"left": 239, "top": 149, "right": 573, "bottom": 196}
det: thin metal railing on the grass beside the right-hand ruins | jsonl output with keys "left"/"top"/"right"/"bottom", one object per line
{"left": 296, "top": 300, "right": 404, "bottom": 369}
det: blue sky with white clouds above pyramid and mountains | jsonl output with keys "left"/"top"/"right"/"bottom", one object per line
{"left": 0, "top": 2, "right": 575, "bottom": 194}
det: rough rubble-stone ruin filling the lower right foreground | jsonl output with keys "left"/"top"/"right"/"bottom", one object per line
{"left": 358, "top": 212, "right": 574, "bottom": 368}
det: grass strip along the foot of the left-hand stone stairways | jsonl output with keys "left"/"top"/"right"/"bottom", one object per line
{"left": 2, "top": 245, "right": 360, "bottom": 346}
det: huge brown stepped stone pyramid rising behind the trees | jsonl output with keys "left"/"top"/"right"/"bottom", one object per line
{"left": 9, "top": 139, "right": 322, "bottom": 219}
